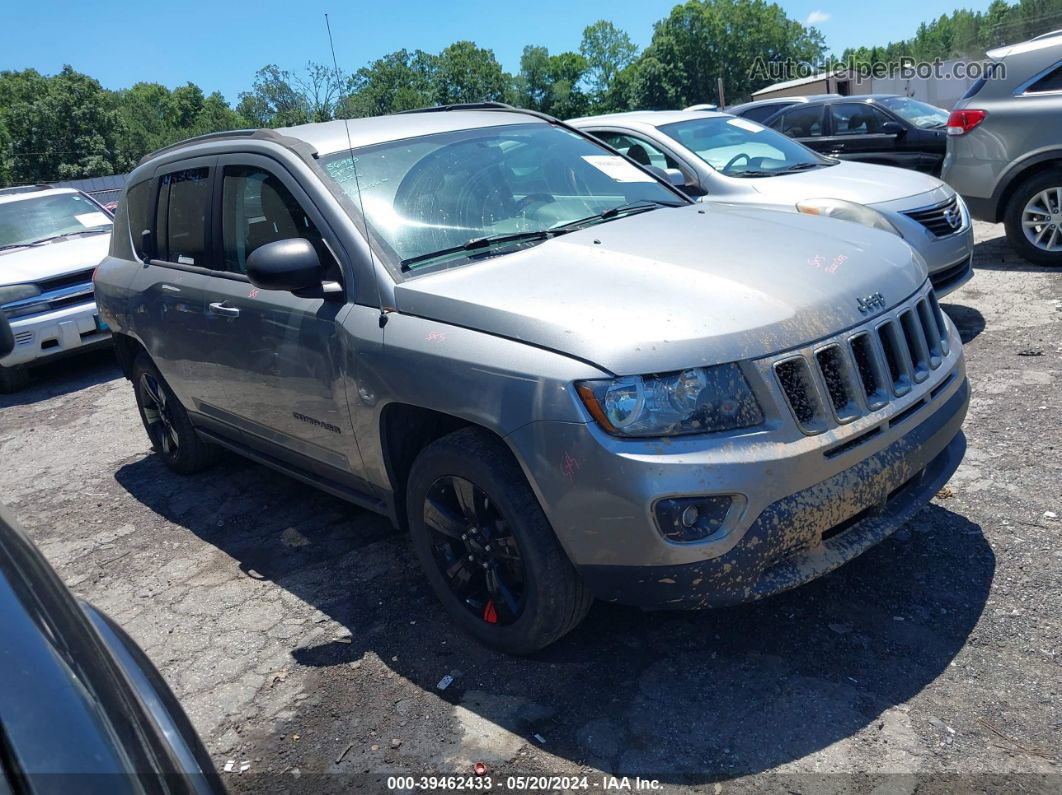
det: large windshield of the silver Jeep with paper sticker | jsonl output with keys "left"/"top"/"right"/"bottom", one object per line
{"left": 321, "top": 123, "right": 682, "bottom": 270}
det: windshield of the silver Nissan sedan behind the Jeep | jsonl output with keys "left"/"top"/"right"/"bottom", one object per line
{"left": 660, "top": 116, "right": 833, "bottom": 177}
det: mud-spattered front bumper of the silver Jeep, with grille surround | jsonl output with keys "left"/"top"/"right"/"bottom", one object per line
{"left": 508, "top": 286, "right": 969, "bottom": 605}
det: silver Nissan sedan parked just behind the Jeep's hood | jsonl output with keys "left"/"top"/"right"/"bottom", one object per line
{"left": 569, "top": 110, "right": 974, "bottom": 296}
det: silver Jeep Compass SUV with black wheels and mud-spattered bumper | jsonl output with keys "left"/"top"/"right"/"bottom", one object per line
{"left": 96, "top": 106, "right": 969, "bottom": 653}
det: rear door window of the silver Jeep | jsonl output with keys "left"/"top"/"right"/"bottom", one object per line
{"left": 157, "top": 168, "right": 210, "bottom": 267}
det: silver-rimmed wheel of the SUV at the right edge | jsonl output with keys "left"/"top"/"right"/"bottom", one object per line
{"left": 1004, "top": 170, "right": 1062, "bottom": 265}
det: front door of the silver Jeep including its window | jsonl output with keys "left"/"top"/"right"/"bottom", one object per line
{"left": 205, "top": 154, "right": 362, "bottom": 480}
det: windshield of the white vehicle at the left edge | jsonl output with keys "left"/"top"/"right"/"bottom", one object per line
{"left": 0, "top": 193, "right": 110, "bottom": 248}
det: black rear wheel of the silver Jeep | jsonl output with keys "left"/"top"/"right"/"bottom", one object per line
{"left": 133, "top": 353, "right": 217, "bottom": 474}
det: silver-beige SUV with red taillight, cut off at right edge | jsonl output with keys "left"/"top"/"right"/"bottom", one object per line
{"left": 942, "top": 31, "right": 1062, "bottom": 265}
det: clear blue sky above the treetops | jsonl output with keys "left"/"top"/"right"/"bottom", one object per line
{"left": 0, "top": 0, "right": 989, "bottom": 101}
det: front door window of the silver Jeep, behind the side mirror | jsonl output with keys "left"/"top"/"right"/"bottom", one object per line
{"left": 221, "top": 166, "right": 329, "bottom": 280}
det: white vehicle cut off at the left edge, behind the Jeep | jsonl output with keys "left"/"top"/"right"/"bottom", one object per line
{"left": 0, "top": 186, "right": 112, "bottom": 393}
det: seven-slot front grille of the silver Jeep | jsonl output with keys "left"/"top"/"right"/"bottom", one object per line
{"left": 772, "top": 290, "right": 948, "bottom": 433}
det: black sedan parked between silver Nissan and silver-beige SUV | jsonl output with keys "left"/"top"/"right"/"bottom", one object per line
{"left": 764, "top": 94, "right": 947, "bottom": 176}
